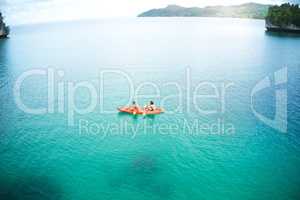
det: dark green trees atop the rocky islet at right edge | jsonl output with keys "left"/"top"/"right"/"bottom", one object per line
{"left": 266, "top": 3, "right": 300, "bottom": 27}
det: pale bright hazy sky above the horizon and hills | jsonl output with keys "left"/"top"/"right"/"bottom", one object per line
{"left": 0, "top": 0, "right": 300, "bottom": 24}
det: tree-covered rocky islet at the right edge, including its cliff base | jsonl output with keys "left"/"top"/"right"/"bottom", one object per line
{"left": 266, "top": 3, "right": 300, "bottom": 33}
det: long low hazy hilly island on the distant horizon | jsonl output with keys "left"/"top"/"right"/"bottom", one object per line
{"left": 138, "top": 3, "right": 271, "bottom": 19}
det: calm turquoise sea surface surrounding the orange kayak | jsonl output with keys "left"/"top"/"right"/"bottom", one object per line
{"left": 0, "top": 18, "right": 300, "bottom": 200}
